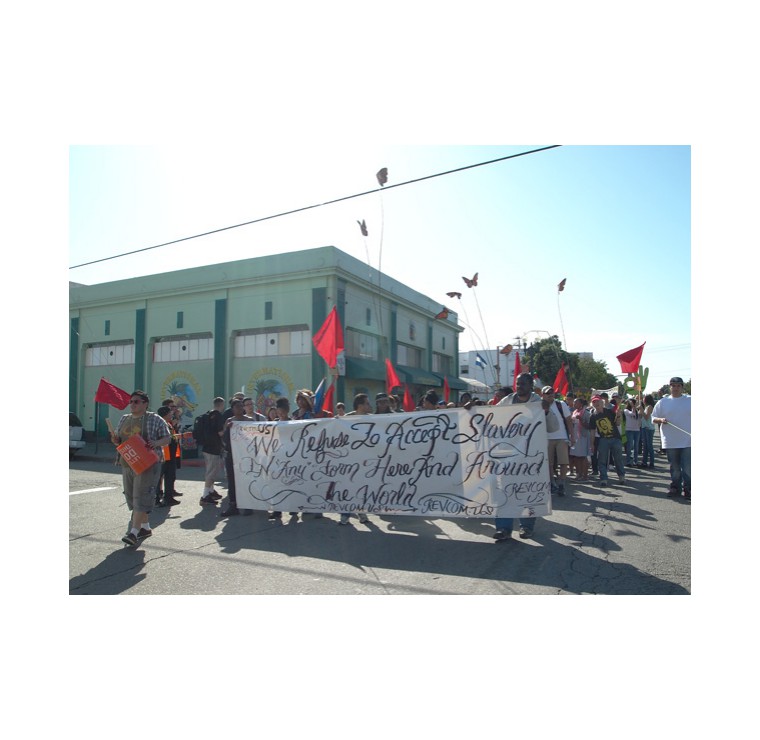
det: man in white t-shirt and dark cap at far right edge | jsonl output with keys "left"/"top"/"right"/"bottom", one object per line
{"left": 652, "top": 377, "right": 691, "bottom": 501}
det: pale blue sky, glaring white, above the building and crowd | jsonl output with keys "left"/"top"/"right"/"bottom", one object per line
{"left": 69, "top": 144, "right": 691, "bottom": 389}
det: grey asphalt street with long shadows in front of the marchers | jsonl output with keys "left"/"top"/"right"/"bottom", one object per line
{"left": 69, "top": 442, "right": 691, "bottom": 595}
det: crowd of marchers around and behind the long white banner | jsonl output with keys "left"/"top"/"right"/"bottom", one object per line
{"left": 111, "top": 373, "right": 691, "bottom": 547}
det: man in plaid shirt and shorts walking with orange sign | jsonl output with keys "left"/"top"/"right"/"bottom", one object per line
{"left": 111, "top": 390, "right": 172, "bottom": 547}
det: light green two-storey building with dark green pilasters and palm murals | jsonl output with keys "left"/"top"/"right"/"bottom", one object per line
{"left": 69, "top": 247, "right": 466, "bottom": 435}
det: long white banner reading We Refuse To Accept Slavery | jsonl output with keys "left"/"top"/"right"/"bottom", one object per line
{"left": 230, "top": 403, "right": 551, "bottom": 518}
